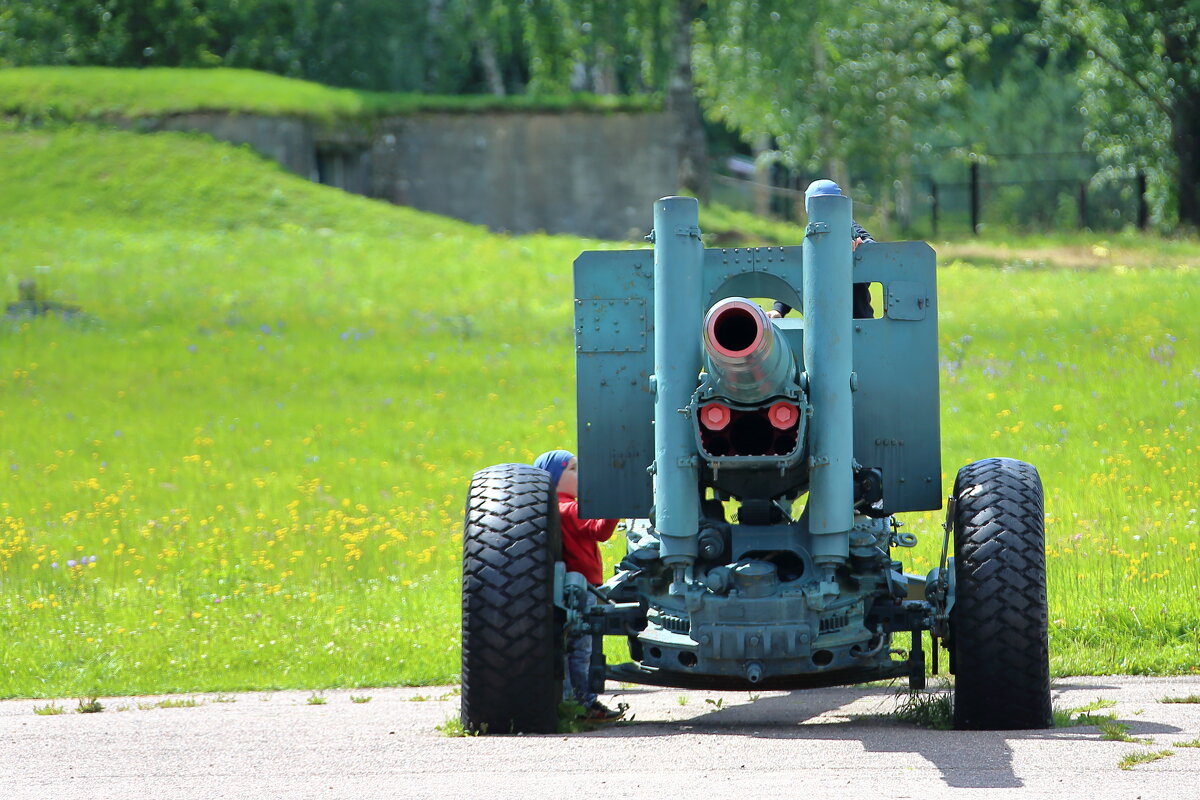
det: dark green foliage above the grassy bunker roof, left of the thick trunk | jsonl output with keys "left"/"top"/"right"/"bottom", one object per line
{"left": 0, "top": 0, "right": 671, "bottom": 95}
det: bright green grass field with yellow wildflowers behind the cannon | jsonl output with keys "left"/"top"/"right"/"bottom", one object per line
{"left": 0, "top": 125, "right": 1200, "bottom": 697}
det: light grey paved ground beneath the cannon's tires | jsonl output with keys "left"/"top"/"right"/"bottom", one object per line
{"left": 0, "top": 676, "right": 1200, "bottom": 800}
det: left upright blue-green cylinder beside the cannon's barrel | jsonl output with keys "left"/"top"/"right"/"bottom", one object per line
{"left": 654, "top": 197, "right": 704, "bottom": 573}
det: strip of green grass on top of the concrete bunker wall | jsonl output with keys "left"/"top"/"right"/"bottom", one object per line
{"left": 0, "top": 67, "right": 661, "bottom": 121}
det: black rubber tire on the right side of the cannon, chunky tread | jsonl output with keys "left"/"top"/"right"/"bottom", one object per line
{"left": 949, "top": 458, "right": 1054, "bottom": 730}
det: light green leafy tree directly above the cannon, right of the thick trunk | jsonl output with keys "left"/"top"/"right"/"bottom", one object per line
{"left": 696, "top": 0, "right": 964, "bottom": 225}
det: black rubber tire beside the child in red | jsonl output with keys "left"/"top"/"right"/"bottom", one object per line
{"left": 461, "top": 464, "right": 565, "bottom": 733}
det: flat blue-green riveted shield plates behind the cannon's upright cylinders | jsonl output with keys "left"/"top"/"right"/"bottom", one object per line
{"left": 575, "top": 242, "right": 942, "bottom": 517}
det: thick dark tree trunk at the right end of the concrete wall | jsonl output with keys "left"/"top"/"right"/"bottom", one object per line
{"left": 667, "top": 0, "right": 708, "bottom": 200}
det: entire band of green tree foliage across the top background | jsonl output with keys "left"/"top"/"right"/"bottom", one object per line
{"left": 0, "top": 0, "right": 1200, "bottom": 228}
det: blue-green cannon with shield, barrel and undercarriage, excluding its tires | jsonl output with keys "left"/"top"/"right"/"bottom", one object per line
{"left": 564, "top": 190, "right": 955, "bottom": 685}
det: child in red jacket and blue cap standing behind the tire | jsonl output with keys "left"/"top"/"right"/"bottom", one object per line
{"left": 533, "top": 450, "right": 623, "bottom": 722}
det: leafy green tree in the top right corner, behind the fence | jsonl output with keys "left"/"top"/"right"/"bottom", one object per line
{"left": 1042, "top": 0, "right": 1200, "bottom": 227}
